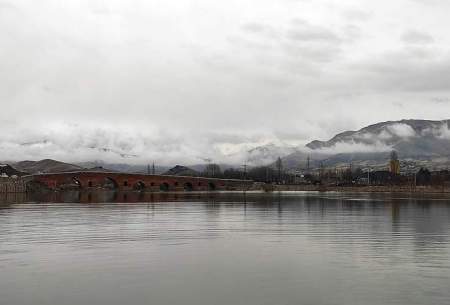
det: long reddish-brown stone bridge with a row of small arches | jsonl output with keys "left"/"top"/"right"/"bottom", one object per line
{"left": 23, "top": 171, "right": 253, "bottom": 191}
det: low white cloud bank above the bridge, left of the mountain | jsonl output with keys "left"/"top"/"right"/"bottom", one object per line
{"left": 0, "top": 123, "right": 296, "bottom": 165}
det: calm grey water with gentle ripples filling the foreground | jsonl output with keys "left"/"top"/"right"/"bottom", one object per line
{"left": 0, "top": 193, "right": 450, "bottom": 305}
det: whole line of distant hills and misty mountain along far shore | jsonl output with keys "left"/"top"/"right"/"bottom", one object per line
{"left": 3, "top": 120, "right": 450, "bottom": 174}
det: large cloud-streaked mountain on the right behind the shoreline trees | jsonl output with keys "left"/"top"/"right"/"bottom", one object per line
{"left": 284, "top": 120, "right": 450, "bottom": 168}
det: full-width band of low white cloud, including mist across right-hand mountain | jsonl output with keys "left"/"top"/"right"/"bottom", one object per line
{"left": 0, "top": 122, "right": 450, "bottom": 166}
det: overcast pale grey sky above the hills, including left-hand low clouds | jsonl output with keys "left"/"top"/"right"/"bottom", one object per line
{"left": 0, "top": 0, "right": 450, "bottom": 165}
